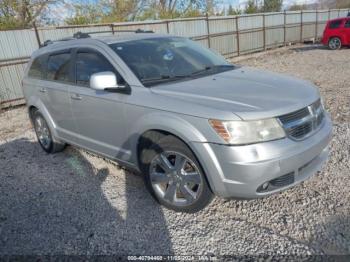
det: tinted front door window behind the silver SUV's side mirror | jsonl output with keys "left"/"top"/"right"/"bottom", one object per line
{"left": 76, "top": 52, "right": 121, "bottom": 86}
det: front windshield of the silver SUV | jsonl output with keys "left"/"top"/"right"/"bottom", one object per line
{"left": 110, "top": 37, "right": 234, "bottom": 86}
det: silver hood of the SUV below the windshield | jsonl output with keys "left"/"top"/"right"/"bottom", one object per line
{"left": 151, "top": 67, "right": 319, "bottom": 120}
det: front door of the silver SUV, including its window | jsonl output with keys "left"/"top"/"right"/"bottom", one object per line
{"left": 69, "top": 48, "right": 130, "bottom": 160}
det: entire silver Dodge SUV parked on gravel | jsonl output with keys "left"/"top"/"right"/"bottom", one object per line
{"left": 23, "top": 30, "right": 332, "bottom": 213}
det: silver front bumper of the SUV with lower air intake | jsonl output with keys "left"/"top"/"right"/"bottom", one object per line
{"left": 191, "top": 116, "right": 332, "bottom": 199}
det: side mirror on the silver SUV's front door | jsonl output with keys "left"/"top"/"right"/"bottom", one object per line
{"left": 90, "top": 71, "right": 125, "bottom": 91}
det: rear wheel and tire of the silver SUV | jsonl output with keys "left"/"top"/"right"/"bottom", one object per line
{"left": 31, "top": 110, "right": 66, "bottom": 154}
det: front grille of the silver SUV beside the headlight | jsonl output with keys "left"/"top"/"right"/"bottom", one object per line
{"left": 279, "top": 100, "right": 324, "bottom": 140}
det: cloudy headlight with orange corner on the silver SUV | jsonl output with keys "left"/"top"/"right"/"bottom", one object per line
{"left": 209, "top": 118, "right": 286, "bottom": 145}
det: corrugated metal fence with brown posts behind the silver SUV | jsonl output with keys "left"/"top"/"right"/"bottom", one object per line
{"left": 0, "top": 9, "right": 350, "bottom": 109}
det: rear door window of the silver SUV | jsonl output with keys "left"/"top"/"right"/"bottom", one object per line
{"left": 47, "top": 53, "right": 71, "bottom": 82}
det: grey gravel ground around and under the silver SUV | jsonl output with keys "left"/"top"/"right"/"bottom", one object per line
{"left": 0, "top": 46, "right": 350, "bottom": 255}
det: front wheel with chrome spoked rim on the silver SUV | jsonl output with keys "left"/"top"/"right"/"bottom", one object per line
{"left": 141, "top": 135, "right": 213, "bottom": 213}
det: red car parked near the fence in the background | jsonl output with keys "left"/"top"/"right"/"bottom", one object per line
{"left": 322, "top": 17, "right": 350, "bottom": 50}
